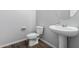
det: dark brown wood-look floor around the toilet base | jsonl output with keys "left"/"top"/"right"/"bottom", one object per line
{"left": 4, "top": 40, "right": 51, "bottom": 48}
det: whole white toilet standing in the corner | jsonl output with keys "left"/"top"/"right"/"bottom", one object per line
{"left": 26, "top": 26, "right": 44, "bottom": 46}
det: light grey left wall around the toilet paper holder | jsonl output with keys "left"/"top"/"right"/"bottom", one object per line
{"left": 0, "top": 10, "right": 36, "bottom": 46}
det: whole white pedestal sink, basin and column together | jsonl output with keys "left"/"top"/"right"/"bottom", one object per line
{"left": 49, "top": 25, "right": 79, "bottom": 48}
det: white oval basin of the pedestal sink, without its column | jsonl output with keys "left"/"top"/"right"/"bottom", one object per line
{"left": 49, "top": 25, "right": 78, "bottom": 36}
